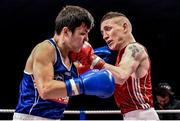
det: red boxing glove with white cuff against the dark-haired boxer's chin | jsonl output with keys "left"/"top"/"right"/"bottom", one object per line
{"left": 70, "top": 41, "right": 105, "bottom": 69}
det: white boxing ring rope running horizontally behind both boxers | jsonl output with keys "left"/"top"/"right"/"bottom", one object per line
{"left": 0, "top": 109, "right": 180, "bottom": 114}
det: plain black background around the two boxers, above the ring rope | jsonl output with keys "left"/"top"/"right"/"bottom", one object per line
{"left": 0, "top": 0, "right": 180, "bottom": 119}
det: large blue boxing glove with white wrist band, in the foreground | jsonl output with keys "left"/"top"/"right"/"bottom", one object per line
{"left": 65, "top": 69, "right": 115, "bottom": 98}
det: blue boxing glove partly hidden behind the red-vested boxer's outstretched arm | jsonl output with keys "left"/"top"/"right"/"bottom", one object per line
{"left": 94, "top": 45, "right": 118, "bottom": 65}
